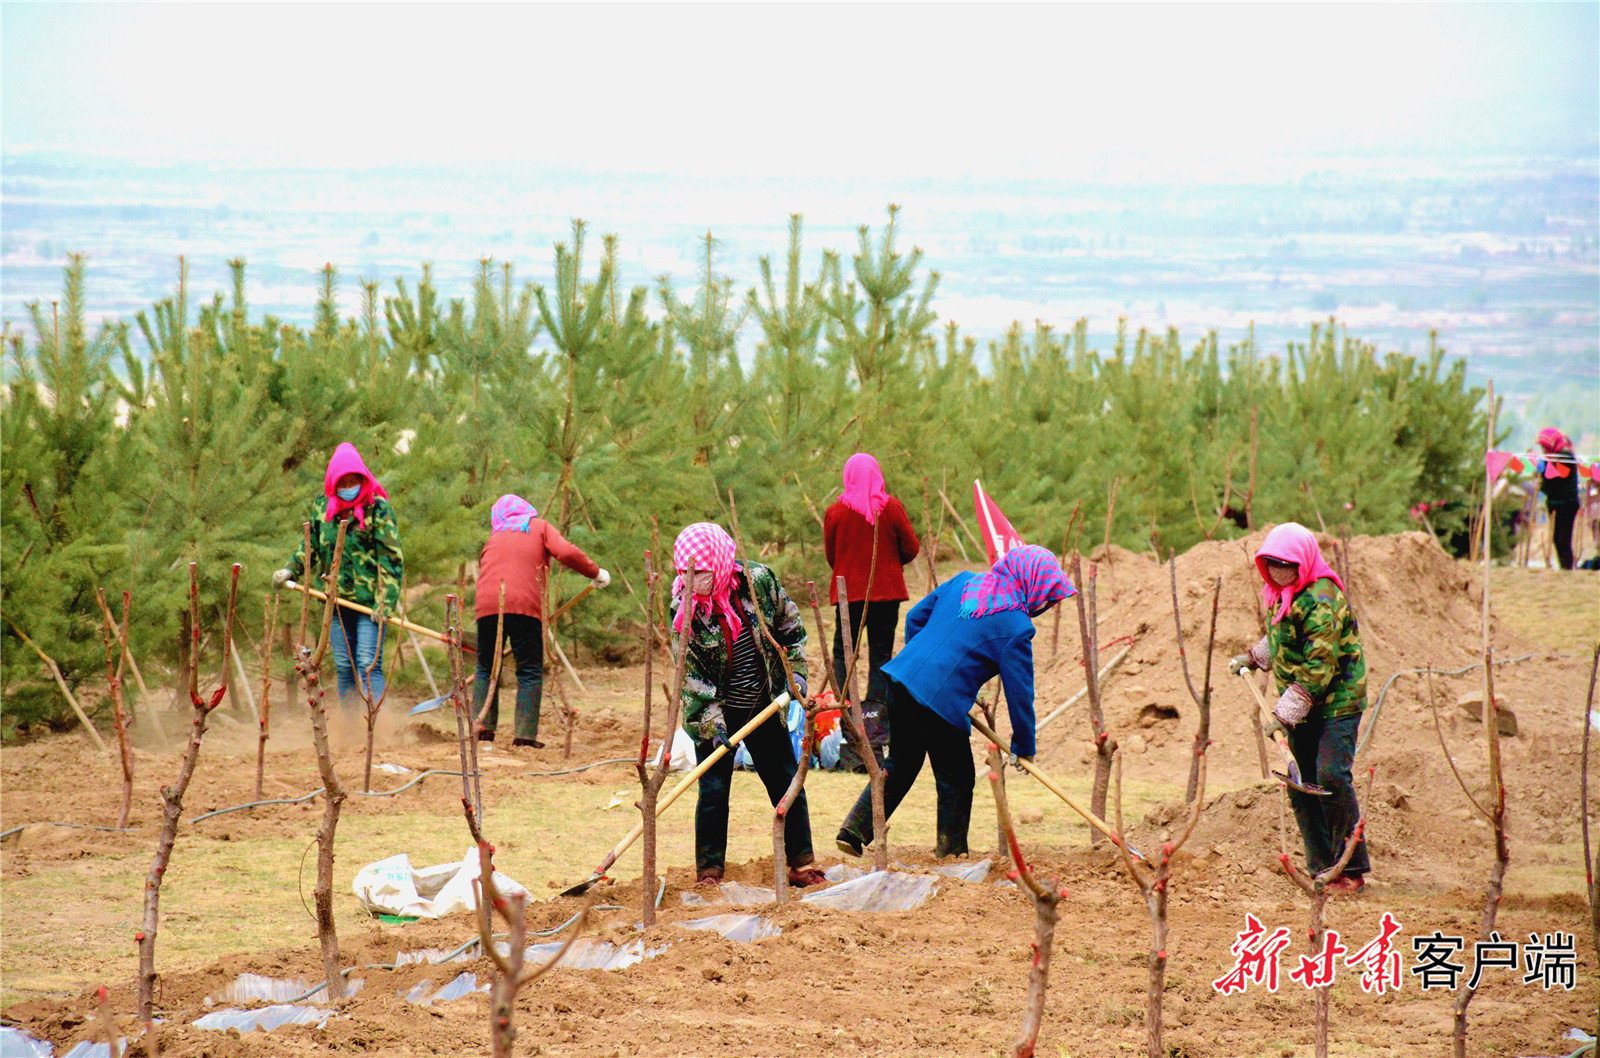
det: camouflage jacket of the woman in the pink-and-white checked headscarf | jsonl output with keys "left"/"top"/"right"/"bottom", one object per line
{"left": 672, "top": 562, "right": 806, "bottom": 741}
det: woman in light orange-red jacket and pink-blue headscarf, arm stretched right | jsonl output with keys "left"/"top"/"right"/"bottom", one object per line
{"left": 472, "top": 493, "right": 611, "bottom": 749}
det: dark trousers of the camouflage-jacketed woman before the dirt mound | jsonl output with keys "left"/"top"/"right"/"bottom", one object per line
{"left": 1290, "top": 712, "right": 1371, "bottom": 877}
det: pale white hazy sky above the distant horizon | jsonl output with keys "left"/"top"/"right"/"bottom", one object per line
{"left": 0, "top": 3, "right": 1600, "bottom": 178}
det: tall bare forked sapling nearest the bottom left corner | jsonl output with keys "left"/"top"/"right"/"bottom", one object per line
{"left": 134, "top": 562, "right": 238, "bottom": 1039}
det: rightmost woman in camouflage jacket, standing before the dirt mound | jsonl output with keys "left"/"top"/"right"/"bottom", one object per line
{"left": 1227, "top": 522, "right": 1371, "bottom": 893}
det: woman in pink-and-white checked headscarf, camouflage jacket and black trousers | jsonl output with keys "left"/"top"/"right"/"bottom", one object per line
{"left": 672, "top": 522, "right": 824, "bottom": 887}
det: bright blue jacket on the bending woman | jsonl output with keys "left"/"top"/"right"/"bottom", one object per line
{"left": 883, "top": 573, "right": 1035, "bottom": 757}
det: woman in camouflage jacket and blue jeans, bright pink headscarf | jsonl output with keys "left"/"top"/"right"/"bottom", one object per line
{"left": 272, "top": 442, "right": 405, "bottom": 706}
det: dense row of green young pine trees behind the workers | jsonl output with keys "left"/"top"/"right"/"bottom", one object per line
{"left": 0, "top": 206, "right": 1486, "bottom": 731}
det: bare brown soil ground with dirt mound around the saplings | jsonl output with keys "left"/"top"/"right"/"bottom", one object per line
{"left": 0, "top": 533, "right": 1600, "bottom": 1058}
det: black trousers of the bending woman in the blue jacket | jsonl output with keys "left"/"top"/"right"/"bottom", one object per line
{"left": 838, "top": 680, "right": 976, "bottom": 856}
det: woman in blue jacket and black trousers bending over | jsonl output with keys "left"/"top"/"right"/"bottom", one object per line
{"left": 838, "top": 544, "right": 1072, "bottom": 856}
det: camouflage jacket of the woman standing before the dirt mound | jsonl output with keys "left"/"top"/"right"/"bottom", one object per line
{"left": 1267, "top": 578, "right": 1366, "bottom": 719}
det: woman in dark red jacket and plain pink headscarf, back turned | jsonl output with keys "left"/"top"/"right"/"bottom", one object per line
{"left": 822, "top": 451, "right": 920, "bottom": 770}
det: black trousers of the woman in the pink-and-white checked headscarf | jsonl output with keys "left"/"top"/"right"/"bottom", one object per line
{"left": 694, "top": 706, "right": 816, "bottom": 871}
